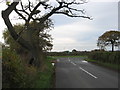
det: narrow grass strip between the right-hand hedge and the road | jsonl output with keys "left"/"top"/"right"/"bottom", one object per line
{"left": 84, "top": 58, "right": 120, "bottom": 71}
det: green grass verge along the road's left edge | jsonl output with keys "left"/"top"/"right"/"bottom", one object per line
{"left": 34, "top": 57, "right": 55, "bottom": 88}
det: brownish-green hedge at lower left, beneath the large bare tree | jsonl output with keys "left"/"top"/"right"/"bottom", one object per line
{"left": 2, "top": 47, "right": 36, "bottom": 88}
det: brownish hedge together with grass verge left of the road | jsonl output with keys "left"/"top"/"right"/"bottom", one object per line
{"left": 2, "top": 47, "right": 54, "bottom": 88}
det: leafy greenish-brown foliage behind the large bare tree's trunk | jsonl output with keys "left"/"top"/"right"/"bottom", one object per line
{"left": 3, "top": 22, "right": 53, "bottom": 53}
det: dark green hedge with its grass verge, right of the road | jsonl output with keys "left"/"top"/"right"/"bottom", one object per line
{"left": 85, "top": 51, "right": 120, "bottom": 70}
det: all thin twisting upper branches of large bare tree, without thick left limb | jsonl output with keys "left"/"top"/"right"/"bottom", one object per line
{"left": 12, "top": 0, "right": 91, "bottom": 27}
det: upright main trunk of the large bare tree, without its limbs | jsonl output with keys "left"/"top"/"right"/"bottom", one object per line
{"left": 26, "top": 27, "right": 44, "bottom": 68}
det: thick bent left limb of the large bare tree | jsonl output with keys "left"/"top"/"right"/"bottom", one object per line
{"left": 2, "top": 2, "right": 31, "bottom": 50}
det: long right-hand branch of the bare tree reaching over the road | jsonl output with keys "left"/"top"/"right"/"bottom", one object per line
{"left": 42, "top": 0, "right": 92, "bottom": 19}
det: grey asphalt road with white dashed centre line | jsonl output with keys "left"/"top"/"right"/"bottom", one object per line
{"left": 56, "top": 57, "right": 118, "bottom": 88}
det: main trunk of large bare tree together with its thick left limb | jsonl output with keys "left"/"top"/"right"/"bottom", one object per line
{"left": 2, "top": 2, "right": 44, "bottom": 67}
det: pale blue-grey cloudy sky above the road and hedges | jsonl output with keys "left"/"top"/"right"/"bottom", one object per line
{"left": 0, "top": 0, "right": 118, "bottom": 51}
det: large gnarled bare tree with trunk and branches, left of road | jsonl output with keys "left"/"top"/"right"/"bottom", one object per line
{"left": 2, "top": 0, "right": 91, "bottom": 67}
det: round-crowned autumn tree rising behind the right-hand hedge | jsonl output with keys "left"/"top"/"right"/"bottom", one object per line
{"left": 97, "top": 31, "right": 120, "bottom": 51}
